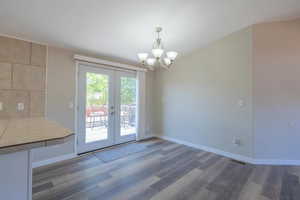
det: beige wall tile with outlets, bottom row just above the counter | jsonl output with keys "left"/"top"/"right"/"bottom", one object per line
{"left": 0, "top": 90, "right": 29, "bottom": 119}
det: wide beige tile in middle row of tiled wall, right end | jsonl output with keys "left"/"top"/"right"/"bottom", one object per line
{"left": 13, "top": 64, "right": 45, "bottom": 91}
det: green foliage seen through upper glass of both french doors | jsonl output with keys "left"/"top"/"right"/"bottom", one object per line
{"left": 86, "top": 73, "right": 136, "bottom": 106}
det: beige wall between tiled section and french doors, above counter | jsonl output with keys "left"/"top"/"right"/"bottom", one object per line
{"left": 46, "top": 47, "right": 76, "bottom": 131}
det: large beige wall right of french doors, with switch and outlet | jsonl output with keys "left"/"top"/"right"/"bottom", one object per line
{"left": 154, "top": 28, "right": 253, "bottom": 156}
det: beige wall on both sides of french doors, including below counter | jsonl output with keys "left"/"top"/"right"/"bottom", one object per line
{"left": 33, "top": 47, "right": 154, "bottom": 162}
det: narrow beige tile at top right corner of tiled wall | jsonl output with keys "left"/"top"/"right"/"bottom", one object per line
{"left": 30, "top": 43, "right": 47, "bottom": 67}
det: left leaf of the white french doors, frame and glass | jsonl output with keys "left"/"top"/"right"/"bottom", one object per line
{"left": 77, "top": 65, "right": 115, "bottom": 153}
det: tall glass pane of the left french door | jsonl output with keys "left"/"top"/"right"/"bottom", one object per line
{"left": 85, "top": 73, "right": 109, "bottom": 143}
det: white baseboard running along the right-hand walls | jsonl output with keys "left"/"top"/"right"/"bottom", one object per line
{"left": 155, "top": 135, "right": 300, "bottom": 166}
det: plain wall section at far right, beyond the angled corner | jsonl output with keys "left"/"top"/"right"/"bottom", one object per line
{"left": 253, "top": 19, "right": 300, "bottom": 160}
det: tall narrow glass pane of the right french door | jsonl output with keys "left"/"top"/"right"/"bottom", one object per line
{"left": 120, "top": 77, "right": 136, "bottom": 136}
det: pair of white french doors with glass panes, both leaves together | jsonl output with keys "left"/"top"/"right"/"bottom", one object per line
{"left": 77, "top": 64, "right": 137, "bottom": 153}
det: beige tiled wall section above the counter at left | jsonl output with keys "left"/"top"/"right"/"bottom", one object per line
{"left": 0, "top": 36, "right": 47, "bottom": 119}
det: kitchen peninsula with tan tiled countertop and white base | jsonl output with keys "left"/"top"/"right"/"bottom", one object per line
{"left": 0, "top": 118, "right": 73, "bottom": 200}
